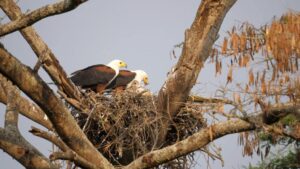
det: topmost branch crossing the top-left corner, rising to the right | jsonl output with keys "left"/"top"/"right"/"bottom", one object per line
{"left": 0, "top": 0, "right": 87, "bottom": 36}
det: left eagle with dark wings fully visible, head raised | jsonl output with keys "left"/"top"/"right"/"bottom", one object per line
{"left": 71, "top": 60, "right": 127, "bottom": 93}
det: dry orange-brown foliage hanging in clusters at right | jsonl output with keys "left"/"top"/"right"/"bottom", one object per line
{"left": 211, "top": 12, "right": 300, "bottom": 109}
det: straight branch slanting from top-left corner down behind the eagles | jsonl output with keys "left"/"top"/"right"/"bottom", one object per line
{"left": 0, "top": 0, "right": 83, "bottom": 100}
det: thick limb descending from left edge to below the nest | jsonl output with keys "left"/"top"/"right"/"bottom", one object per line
{"left": 0, "top": 43, "right": 113, "bottom": 168}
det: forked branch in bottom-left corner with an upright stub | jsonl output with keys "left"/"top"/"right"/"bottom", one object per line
{"left": 0, "top": 87, "right": 58, "bottom": 169}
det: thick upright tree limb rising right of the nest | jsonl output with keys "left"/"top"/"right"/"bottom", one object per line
{"left": 158, "top": 0, "right": 236, "bottom": 145}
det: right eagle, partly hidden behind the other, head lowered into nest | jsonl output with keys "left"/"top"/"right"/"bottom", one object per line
{"left": 106, "top": 70, "right": 149, "bottom": 91}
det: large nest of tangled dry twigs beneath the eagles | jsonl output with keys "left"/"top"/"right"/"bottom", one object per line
{"left": 72, "top": 91, "right": 205, "bottom": 168}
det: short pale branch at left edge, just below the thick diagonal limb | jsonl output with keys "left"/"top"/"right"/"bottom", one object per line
{"left": 0, "top": 74, "right": 53, "bottom": 130}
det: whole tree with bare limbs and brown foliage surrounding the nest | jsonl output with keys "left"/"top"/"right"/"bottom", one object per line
{"left": 0, "top": 1, "right": 299, "bottom": 168}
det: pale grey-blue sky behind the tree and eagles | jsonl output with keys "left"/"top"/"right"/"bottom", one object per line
{"left": 0, "top": 0, "right": 300, "bottom": 169}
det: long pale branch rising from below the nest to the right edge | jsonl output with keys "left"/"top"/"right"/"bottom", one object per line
{"left": 124, "top": 105, "right": 299, "bottom": 169}
